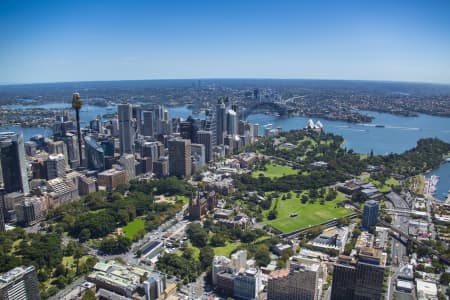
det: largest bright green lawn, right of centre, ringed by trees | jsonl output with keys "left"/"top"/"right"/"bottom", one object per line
{"left": 264, "top": 193, "right": 351, "bottom": 233}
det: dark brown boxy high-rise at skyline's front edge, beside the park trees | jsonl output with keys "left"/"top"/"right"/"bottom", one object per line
{"left": 168, "top": 139, "right": 192, "bottom": 177}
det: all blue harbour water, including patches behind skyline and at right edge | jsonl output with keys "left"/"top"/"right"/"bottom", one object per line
{"left": 0, "top": 103, "right": 450, "bottom": 200}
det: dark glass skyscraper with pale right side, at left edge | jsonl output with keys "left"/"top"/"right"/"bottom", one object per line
{"left": 0, "top": 132, "right": 30, "bottom": 194}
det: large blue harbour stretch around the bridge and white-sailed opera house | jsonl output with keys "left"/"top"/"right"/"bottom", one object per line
{"left": 248, "top": 111, "right": 450, "bottom": 154}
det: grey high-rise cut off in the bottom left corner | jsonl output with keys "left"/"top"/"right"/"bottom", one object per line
{"left": 0, "top": 266, "right": 41, "bottom": 300}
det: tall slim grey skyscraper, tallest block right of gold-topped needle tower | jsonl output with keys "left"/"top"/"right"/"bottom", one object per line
{"left": 118, "top": 104, "right": 134, "bottom": 154}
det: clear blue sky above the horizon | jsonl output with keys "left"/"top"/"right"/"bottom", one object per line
{"left": 0, "top": 0, "right": 450, "bottom": 83}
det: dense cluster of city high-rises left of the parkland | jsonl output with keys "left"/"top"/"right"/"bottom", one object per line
{"left": 0, "top": 93, "right": 258, "bottom": 229}
